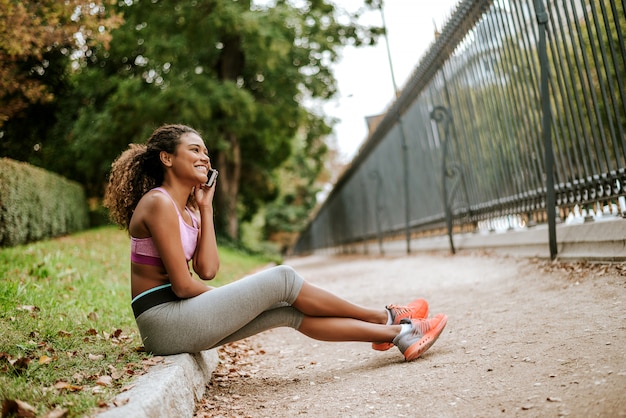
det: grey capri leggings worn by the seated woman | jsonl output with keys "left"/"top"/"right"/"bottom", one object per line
{"left": 136, "top": 266, "right": 304, "bottom": 355}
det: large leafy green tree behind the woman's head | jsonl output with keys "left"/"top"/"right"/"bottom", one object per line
{"left": 68, "top": 0, "right": 379, "bottom": 238}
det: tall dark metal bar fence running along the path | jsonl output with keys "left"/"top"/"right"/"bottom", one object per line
{"left": 294, "top": 0, "right": 626, "bottom": 253}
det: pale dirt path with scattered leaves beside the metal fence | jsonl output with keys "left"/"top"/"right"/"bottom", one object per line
{"left": 197, "top": 254, "right": 626, "bottom": 417}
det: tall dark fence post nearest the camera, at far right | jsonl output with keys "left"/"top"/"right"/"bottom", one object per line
{"left": 535, "top": 0, "right": 557, "bottom": 260}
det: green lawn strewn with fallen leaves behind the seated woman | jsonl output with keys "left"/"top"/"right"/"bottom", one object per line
{"left": 0, "top": 227, "right": 271, "bottom": 417}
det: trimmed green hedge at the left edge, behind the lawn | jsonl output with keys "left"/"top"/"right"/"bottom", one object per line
{"left": 0, "top": 158, "right": 89, "bottom": 247}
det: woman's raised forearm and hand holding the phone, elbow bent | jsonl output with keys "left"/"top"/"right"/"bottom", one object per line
{"left": 193, "top": 185, "right": 220, "bottom": 280}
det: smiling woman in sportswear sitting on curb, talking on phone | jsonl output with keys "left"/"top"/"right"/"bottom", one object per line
{"left": 104, "top": 125, "right": 447, "bottom": 361}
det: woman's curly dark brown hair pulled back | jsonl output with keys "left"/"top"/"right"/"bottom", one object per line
{"left": 103, "top": 125, "right": 200, "bottom": 230}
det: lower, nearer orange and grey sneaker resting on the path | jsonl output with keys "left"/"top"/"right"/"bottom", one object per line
{"left": 393, "top": 314, "right": 448, "bottom": 361}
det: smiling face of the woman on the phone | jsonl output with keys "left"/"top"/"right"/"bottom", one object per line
{"left": 171, "top": 133, "right": 211, "bottom": 184}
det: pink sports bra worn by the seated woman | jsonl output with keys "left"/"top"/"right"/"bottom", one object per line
{"left": 130, "top": 187, "right": 198, "bottom": 267}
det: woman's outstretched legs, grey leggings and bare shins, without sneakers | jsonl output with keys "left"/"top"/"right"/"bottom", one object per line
{"left": 137, "top": 266, "right": 410, "bottom": 354}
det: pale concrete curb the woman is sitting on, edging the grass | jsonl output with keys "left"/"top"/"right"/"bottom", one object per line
{"left": 96, "top": 349, "right": 218, "bottom": 418}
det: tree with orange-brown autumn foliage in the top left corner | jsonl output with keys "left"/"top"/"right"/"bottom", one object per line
{"left": 0, "top": 0, "right": 121, "bottom": 127}
